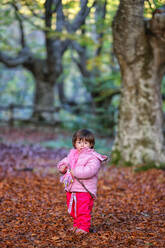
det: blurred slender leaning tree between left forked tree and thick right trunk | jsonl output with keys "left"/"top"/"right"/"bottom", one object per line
{"left": 72, "top": 0, "right": 120, "bottom": 128}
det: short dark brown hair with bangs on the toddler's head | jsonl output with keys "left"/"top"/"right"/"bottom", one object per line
{"left": 72, "top": 129, "right": 95, "bottom": 148}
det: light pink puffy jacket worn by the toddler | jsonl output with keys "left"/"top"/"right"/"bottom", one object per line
{"left": 57, "top": 148, "right": 107, "bottom": 196}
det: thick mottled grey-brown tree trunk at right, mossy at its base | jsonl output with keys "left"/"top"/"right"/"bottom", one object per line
{"left": 112, "top": 0, "right": 165, "bottom": 166}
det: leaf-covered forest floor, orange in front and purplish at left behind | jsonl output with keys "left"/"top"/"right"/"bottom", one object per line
{"left": 0, "top": 127, "right": 165, "bottom": 248}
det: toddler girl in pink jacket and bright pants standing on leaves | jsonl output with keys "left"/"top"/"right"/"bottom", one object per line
{"left": 57, "top": 129, "right": 107, "bottom": 233}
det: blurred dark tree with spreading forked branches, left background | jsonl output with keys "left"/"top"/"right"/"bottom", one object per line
{"left": 0, "top": 0, "right": 94, "bottom": 120}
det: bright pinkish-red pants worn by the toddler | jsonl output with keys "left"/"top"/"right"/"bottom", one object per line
{"left": 66, "top": 192, "right": 94, "bottom": 232}
